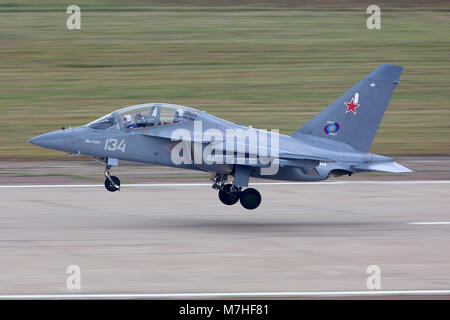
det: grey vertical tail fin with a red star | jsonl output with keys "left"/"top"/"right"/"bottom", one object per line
{"left": 292, "top": 64, "right": 403, "bottom": 152}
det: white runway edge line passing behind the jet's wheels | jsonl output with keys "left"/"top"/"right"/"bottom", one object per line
{"left": 0, "top": 180, "right": 450, "bottom": 189}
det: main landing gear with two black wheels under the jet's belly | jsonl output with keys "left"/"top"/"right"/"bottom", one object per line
{"left": 212, "top": 173, "right": 261, "bottom": 210}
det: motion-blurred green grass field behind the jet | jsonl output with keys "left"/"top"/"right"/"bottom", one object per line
{"left": 0, "top": 0, "right": 450, "bottom": 160}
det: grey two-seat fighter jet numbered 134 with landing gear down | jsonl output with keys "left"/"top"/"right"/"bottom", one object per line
{"left": 29, "top": 64, "right": 411, "bottom": 209}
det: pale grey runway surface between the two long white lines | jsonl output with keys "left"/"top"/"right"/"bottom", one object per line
{"left": 0, "top": 180, "right": 450, "bottom": 295}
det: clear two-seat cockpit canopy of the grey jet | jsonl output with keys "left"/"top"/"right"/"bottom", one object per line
{"left": 87, "top": 103, "right": 198, "bottom": 130}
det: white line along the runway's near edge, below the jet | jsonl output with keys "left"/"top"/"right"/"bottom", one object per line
{"left": 0, "top": 290, "right": 450, "bottom": 300}
